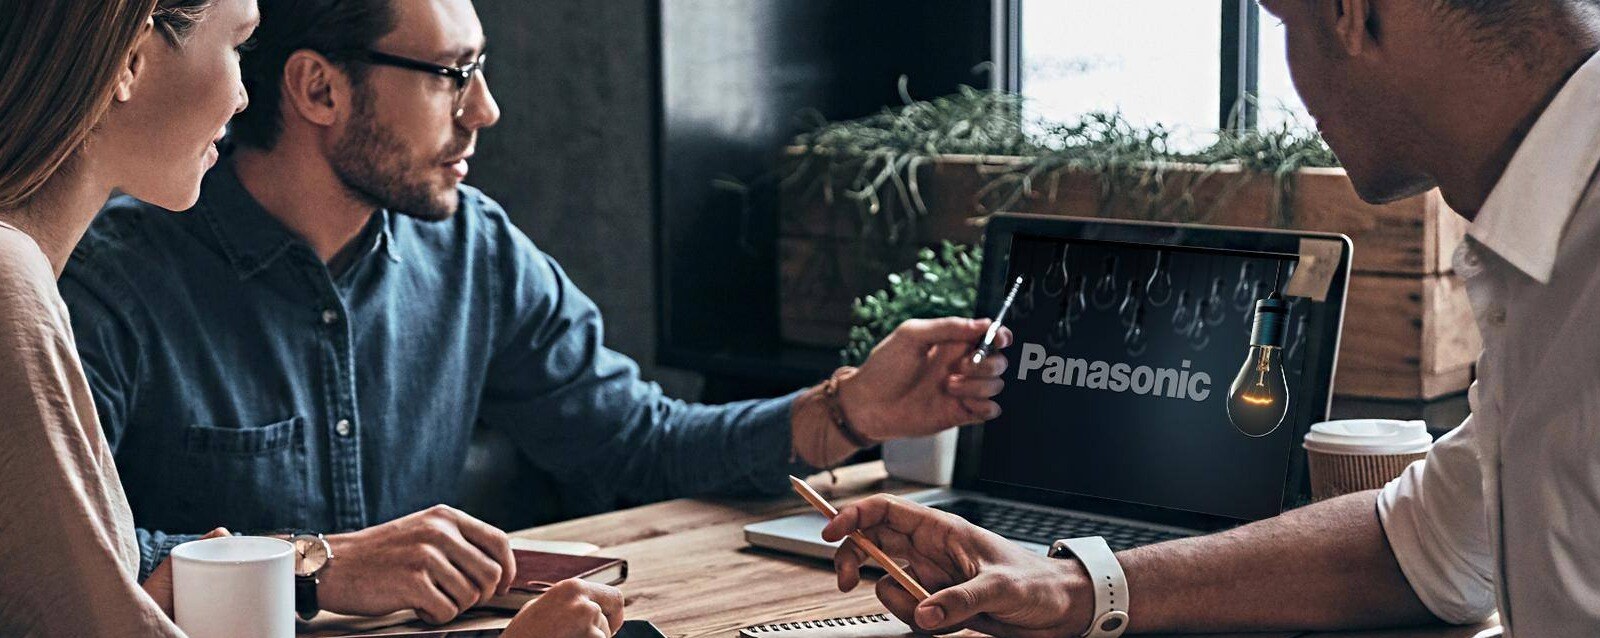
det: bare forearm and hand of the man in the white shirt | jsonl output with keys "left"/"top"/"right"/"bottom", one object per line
{"left": 824, "top": 491, "right": 1437, "bottom": 636}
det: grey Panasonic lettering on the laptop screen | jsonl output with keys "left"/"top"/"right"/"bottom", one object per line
{"left": 1016, "top": 344, "right": 1211, "bottom": 401}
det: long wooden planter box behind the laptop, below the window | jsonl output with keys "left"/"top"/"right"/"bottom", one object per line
{"left": 778, "top": 155, "right": 1482, "bottom": 398}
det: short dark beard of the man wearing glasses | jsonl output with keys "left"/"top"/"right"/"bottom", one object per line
{"left": 330, "top": 90, "right": 472, "bottom": 221}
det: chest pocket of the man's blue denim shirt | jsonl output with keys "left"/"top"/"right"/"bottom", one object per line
{"left": 178, "top": 417, "right": 310, "bottom": 532}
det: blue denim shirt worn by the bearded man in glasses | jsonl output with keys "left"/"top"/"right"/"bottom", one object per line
{"left": 61, "top": 160, "right": 795, "bottom": 579}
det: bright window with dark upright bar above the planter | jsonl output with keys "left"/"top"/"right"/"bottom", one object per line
{"left": 1011, "top": 0, "right": 1312, "bottom": 149}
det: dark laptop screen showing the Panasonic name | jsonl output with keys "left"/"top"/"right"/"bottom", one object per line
{"left": 974, "top": 233, "right": 1326, "bottom": 520}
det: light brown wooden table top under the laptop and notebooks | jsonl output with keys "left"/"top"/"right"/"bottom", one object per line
{"left": 305, "top": 462, "right": 1483, "bottom": 638}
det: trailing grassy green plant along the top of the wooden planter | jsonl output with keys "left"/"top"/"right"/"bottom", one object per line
{"left": 781, "top": 77, "right": 1338, "bottom": 236}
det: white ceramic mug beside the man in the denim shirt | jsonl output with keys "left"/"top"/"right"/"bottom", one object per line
{"left": 171, "top": 536, "right": 294, "bottom": 638}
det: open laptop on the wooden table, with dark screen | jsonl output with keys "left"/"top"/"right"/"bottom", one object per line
{"left": 744, "top": 214, "right": 1352, "bottom": 558}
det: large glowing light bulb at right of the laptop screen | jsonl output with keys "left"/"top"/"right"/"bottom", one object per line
{"left": 1227, "top": 293, "right": 1290, "bottom": 437}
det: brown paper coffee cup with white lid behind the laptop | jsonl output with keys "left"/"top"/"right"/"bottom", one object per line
{"left": 1304, "top": 419, "right": 1434, "bottom": 500}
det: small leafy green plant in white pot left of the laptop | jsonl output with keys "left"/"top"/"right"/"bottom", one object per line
{"left": 840, "top": 241, "right": 982, "bottom": 366}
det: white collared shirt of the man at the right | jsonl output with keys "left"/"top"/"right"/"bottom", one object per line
{"left": 1378, "top": 48, "right": 1600, "bottom": 636}
